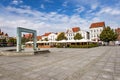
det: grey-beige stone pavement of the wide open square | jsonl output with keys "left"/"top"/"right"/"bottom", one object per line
{"left": 0, "top": 46, "right": 120, "bottom": 80}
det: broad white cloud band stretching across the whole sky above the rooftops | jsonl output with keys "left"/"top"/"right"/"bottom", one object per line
{"left": 0, "top": 6, "right": 120, "bottom": 36}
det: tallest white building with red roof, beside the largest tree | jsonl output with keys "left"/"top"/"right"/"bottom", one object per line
{"left": 89, "top": 22, "right": 105, "bottom": 41}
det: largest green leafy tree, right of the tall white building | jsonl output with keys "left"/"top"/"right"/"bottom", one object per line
{"left": 100, "top": 26, "right": 117, "bottom": 43}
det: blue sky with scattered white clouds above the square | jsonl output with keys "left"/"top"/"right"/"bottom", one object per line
{"left": 0, "top": 0, "right": 120, "bottom": 36}
